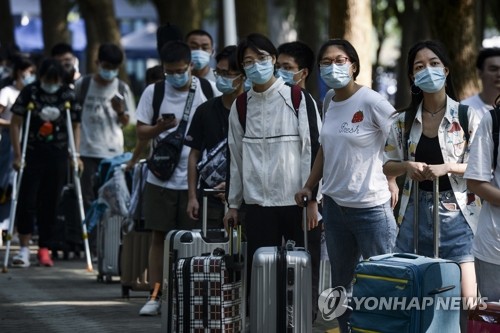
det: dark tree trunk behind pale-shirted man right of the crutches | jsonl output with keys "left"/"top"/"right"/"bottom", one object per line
{"left": 79, "top": 0, "right": 122, "bottom": 80}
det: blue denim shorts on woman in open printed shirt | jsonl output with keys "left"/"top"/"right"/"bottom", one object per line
{"left": 394, "top": 190, "right": 474, "bottom": 263}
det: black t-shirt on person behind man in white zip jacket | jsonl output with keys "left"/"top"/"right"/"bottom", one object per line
{"left": 184, "top": 96, "right": 229, "bottom": 153}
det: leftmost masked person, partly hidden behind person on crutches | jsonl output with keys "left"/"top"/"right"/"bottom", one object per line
{"left": 0, "top": 56, "right": 36, "bottom": 230}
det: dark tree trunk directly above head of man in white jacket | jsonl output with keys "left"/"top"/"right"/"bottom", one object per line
{"left": 236, "top": 0, "right": 269, "bottom": 39}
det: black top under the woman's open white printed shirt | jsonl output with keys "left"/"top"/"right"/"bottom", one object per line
{"left": 415, "top": 134, "right": 451, "bottom": 192}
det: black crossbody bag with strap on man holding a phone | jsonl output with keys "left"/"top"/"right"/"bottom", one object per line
{"left": 146, "top": 80, "right": 196, "bottom": 181}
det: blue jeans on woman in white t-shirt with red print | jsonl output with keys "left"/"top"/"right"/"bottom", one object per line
{"left": 320, "top": 196, "right": 396, "bottom": 332}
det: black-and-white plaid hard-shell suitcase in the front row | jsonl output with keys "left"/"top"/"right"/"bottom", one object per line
{"left": 172, "top": 222, "right": 245, "bottom": 333}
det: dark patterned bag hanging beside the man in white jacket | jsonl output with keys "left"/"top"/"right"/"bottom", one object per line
{"left": 196, "top": 138, "right": 227, "bottom": 188}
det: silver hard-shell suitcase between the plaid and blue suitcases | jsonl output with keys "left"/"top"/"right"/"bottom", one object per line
{"left": 250, "top": 197, "right": 313, "bottom": 333}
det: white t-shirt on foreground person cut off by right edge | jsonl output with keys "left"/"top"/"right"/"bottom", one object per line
{"left": 464, "top": 112, "right": 500, "bottom": 265}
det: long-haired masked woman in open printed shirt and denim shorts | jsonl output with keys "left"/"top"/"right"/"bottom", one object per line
{"left": 384, "top": 41, "right": 481, "bottom": 329}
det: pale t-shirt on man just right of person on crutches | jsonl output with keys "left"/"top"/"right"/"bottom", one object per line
{"left": 76, "top": 78, "right": 135, "bottom": 158}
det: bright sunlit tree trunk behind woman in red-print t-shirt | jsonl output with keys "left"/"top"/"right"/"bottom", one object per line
{"left": 329, "top": 0, "right": 374, "bottom": 87}
